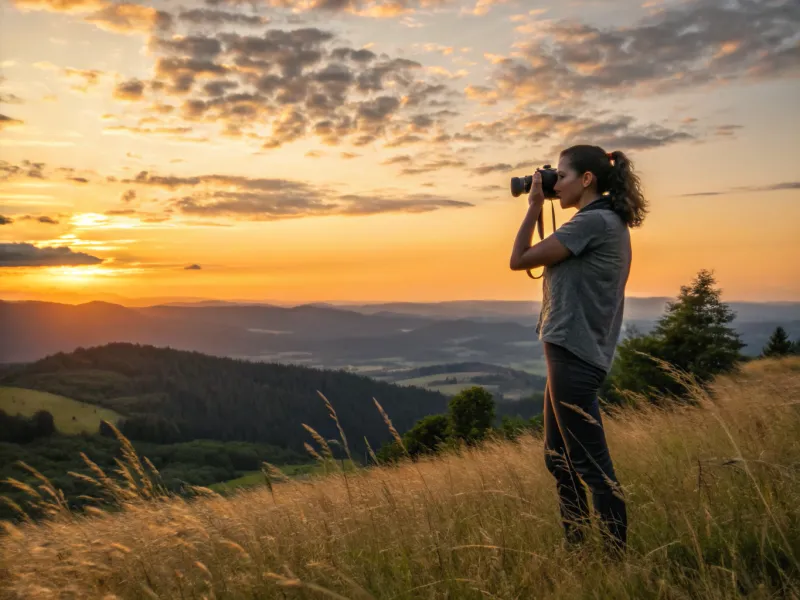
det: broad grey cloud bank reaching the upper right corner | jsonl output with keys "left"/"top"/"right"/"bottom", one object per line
{"left": 494, "top": 0, "right": 800, "bottom": 105}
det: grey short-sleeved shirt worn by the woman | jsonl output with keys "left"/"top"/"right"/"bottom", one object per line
{"left": 536, "top": 204, "right": 631, "bottom": 372}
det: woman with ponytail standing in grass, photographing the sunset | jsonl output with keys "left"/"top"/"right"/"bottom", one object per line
{"left": 511, "top": 145, "right": 647, "bottom": 556}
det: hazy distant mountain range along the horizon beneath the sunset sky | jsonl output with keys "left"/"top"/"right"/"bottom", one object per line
{"left": 0, "top": 298, "right": 800, "bottom": 374}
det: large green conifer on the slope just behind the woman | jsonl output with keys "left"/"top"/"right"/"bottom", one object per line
{"left": 603, "top": 270, "right": 745, "bottom": 401}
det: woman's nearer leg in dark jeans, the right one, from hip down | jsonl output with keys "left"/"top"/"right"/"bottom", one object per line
{"left": 544, "top": 343, "right": 627, "bottom": 550}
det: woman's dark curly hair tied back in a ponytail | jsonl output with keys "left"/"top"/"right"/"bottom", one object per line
{"left": 561, "top": 145, "right": 647, "bottom": 227}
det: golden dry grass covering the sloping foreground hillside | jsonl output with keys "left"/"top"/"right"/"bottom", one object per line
{"left": 0, "top": 358, "right": 800, "bottom": 599}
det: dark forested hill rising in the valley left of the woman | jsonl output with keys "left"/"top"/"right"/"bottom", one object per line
{"left": 0, "top": 343, "right": 447, "bottom": 453}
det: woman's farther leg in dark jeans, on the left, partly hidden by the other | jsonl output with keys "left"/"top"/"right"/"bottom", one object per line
{"left": 544, "top": 384, "right": 589, "bottom": 544}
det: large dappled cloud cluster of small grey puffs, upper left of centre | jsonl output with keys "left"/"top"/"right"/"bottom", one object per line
{"left": 106, "top": 27, "right": 460, "bottom": 149}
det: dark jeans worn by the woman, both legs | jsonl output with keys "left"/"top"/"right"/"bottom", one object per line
{"left": 544, "top": 342, "right": 628, "bottom": 553}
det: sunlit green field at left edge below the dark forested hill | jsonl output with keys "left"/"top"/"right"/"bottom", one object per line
{"left": 0, "top": 386, "right": 120, "bottom": 434}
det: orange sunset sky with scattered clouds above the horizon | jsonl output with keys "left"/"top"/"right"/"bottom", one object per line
{"left": 0, "top": 0, "right": 800, "bottom": 304}
